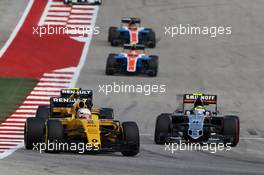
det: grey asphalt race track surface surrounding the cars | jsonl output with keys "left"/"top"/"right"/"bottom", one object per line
{"left": 0, "top": 0, "right": 264, "bottom": 175}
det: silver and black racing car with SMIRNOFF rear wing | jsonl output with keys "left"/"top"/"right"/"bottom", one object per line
{"left": 155, "top": 93, "right": 240, "bottom": 146}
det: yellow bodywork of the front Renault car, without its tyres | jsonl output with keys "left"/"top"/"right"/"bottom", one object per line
{"left": 49, "top": 101, "right": 120, "bottom": 148}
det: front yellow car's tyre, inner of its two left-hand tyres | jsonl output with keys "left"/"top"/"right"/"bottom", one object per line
{"left": 46, "top": 120, "right": 64, "bottom": 153}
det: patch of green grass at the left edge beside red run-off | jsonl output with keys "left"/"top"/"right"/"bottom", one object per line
{"left": 0, "top": 78, "right": 37, "bottom": 120}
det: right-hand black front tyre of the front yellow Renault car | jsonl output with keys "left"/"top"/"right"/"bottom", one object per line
{"left": 121, "top": 122, "right": 140, "bottom": 156}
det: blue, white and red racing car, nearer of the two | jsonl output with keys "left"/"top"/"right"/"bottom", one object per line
{"left": 105, "top": 45, "right": 159, "bottom": 77}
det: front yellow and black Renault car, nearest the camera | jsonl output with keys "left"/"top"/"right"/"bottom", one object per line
{"left": 24, "top": 90, "right": 140, "bottom": 156}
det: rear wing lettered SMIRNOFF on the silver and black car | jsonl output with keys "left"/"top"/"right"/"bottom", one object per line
{"left": 183, "top": 93, "right": 217, "bottom": 105}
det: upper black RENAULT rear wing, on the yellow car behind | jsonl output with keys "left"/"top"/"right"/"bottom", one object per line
{"left": 60, "top": 88, "right": 93, "bottom": 100}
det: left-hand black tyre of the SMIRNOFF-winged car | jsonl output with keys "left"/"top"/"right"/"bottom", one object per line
{"left": 154, "top": 113, "right": 171, "bottom": 144}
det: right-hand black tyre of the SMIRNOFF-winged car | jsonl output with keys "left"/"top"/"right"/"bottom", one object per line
{"left": 223, "top": 115, "right": 240, "bottom": 147}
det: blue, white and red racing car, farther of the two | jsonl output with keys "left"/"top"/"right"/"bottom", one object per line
{"left": 108, "top": 17, "right": 156, "bottom": 48}
